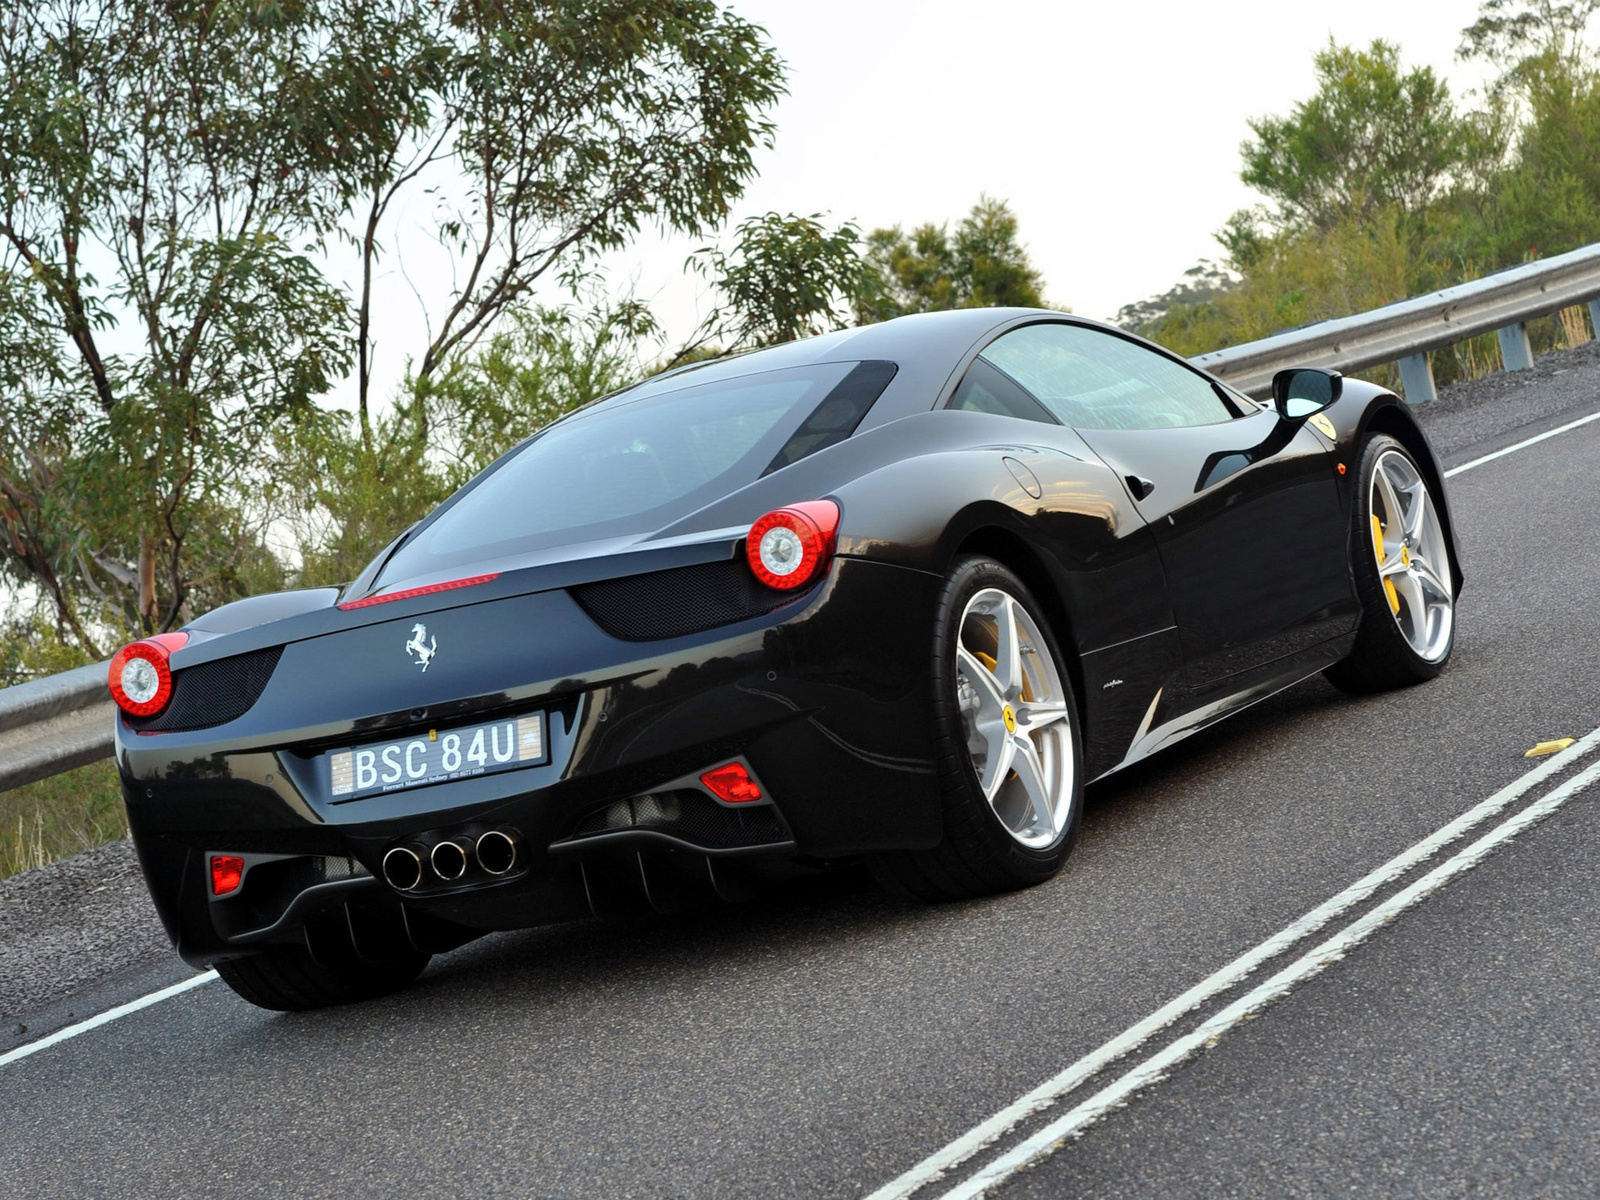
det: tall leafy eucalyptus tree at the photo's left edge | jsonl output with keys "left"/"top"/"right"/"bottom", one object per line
{"left": 0, "top": 0, "right": 365, "bottom": 653}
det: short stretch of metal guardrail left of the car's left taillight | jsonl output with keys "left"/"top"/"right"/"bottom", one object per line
{"left": 0, "top": 662, "right": 117, "bottom": 792}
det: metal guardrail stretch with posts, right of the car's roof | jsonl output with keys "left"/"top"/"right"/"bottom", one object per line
{"left": 1189, "top": 245, "right": 1600, "bottom": 405}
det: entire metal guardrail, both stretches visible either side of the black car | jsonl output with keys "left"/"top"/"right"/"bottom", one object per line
{"left": 0, "top": 245, "right": 1600, "bottom": 790}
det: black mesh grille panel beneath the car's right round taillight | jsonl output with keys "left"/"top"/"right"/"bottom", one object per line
{"left": 571, "top": 558, "right": 795, "bottom": 642}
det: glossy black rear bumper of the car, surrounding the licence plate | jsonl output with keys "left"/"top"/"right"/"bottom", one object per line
{"left": 117, "top": 558, "right": 941, "bottom": 965}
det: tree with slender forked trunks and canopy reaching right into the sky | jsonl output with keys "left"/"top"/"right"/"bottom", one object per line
{"left": 350, "top": 0, "right": 782, "bottom": 448}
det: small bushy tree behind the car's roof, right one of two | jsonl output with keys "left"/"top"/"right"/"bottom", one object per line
{"left": 856, "top": 197, "right": 1045, "bottom": 323}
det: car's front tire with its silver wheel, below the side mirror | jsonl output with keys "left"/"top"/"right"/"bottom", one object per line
{"left": 1325, "top": 434, "right": 1456, "bottom": 694}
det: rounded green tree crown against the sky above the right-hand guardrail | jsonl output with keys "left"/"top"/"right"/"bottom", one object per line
{"left": 1240, "top": 40, "right": 1498, "bottom": 229}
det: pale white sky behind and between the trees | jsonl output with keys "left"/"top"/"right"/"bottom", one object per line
{"left": 350, "top": 0, "right": 1482, "bottom": 404}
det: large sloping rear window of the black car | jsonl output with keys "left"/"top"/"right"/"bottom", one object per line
{"left": 374, "top": 362, "right": 894, "bottom": 586}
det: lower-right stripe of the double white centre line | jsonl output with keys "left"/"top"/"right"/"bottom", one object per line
{"left": 941, "top": 763, "right": 1600, "bottom": 1200}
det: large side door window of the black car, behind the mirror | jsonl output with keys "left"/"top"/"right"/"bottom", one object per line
{"left": 957, "top": 325, "right": 1234, "bottom": 429}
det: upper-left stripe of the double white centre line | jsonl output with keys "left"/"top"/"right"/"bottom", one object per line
{"left": 867, "top": 728, "right": 1600, "bottom": 1200}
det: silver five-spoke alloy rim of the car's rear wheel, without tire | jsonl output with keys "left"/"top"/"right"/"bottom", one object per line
{"left": 955, "top": 587, "right": 1077, "bottom": 850}
